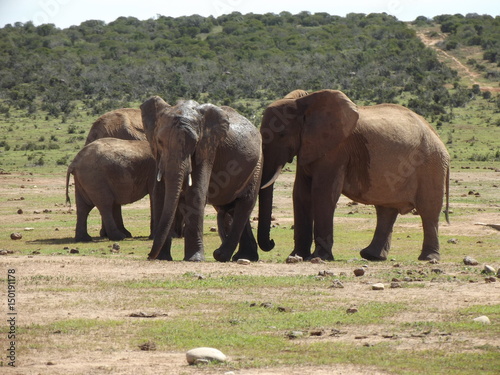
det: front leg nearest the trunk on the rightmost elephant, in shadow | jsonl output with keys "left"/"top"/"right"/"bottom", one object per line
{"left": 290, "top": 167, "right": 313, "bottom": 259}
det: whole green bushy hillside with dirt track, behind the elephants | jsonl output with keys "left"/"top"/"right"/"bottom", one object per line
{"left": 0, "top": 12, "right": 500, "bottom": 170}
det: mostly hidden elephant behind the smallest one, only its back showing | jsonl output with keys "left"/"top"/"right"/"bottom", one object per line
{"left": 85, "top": 108, "right": 147, "bottom": 145}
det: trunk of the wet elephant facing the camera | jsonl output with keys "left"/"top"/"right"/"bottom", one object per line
{"left": 148, "top": 168, "right": 186, "bottom": 260}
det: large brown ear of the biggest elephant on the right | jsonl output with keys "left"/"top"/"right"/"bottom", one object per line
{"left": 296, "top": 90, "right": 359, "bottom": 165}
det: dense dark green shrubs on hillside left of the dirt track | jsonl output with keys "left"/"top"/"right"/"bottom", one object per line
{"left": 0, "top": 12, "right": 482, "bottom": 120}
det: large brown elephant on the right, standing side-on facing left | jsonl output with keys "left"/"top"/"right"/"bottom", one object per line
{"left": 257, "top": 90, "right": 450, "bottom": 261}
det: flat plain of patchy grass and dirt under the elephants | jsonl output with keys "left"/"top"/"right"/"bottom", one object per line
{"left": 0, "top": 32, "right": 500, "bottom": 374}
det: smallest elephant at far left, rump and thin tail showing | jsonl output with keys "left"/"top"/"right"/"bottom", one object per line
{"left": 66, "top": 138, "right": 156, "bottom": 242}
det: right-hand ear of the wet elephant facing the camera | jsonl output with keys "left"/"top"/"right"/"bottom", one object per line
{"left": 196, "top": 104, "right": 229, "bottom": 164}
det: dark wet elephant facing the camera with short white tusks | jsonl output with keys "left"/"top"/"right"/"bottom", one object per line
{"left": 141, "top": 96, "right": 263, "bottom": 262}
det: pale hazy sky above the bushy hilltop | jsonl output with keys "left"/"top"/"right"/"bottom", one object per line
{"left": 0, "top": 0, "right": 500, "bottom": 28}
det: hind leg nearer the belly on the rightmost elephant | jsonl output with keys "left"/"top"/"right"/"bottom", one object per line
{"left": 360, "top": 206, "right": 399, "bottom": 261}
